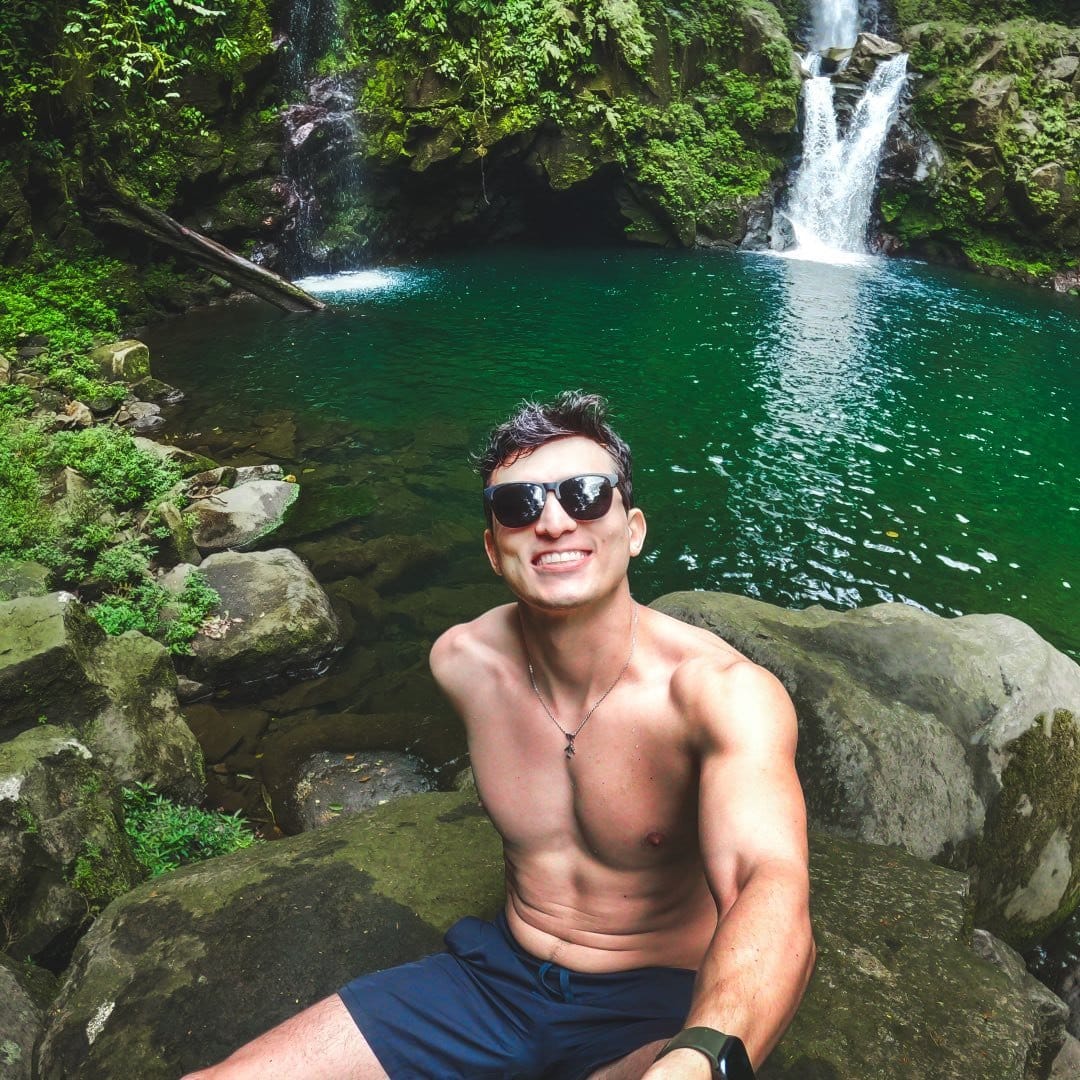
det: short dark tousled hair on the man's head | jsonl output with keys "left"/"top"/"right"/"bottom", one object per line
{"left": 473, "top": 390, "right": 634, "bottom": 525}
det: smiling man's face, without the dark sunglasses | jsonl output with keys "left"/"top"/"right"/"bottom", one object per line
{"left": 484, "top": 435, "right": 645, "bottom": 610}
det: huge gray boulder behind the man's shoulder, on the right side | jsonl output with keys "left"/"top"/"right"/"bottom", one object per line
{"left": 653, "top": 593, "right": 1080, "bottom": 946}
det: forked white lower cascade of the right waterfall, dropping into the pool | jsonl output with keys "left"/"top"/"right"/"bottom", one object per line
{"left": 784, "top": 53, "right": 907, "bottom": 252}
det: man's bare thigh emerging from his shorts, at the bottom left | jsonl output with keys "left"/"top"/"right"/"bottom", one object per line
{"left": 184, "top": 994, "right": 387, "bottom": 1080}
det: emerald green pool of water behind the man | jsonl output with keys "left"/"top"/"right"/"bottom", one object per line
{"left": 151, "top": 248, "right": 1080, "bottom": 656}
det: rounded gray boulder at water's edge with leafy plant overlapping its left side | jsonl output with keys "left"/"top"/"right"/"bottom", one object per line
{"left": 187, "top": 552, "right": 338, "bottom": 686}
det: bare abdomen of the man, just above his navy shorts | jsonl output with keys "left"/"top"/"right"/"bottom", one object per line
{"left": 505, "top": 846, "right": 716, "bottom": 974}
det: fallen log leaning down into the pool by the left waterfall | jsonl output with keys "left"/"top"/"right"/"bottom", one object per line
{"left": 91, "top": 175, "right": 326, "bottom": 311}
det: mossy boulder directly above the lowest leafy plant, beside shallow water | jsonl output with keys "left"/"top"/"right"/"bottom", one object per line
{"left": 80, "top": 630, "right": 204, "bottom": 802}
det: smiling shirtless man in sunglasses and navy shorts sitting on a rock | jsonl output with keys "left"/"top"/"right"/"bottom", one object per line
{"left": 187, "top": 393, "right": 814, "bottom": 1080}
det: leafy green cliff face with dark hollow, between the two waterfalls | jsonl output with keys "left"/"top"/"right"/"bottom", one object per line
{"left": 287, "top": 0, "right": 799, "bottom": 264}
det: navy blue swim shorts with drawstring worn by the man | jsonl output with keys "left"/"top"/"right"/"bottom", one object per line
{"left": 338, "top": 914, "right": 697, "bottom": 1080}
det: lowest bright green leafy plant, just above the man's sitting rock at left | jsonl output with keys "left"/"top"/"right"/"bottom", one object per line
{"left": 123, "top": 783, "right": 256, "bottom": 878}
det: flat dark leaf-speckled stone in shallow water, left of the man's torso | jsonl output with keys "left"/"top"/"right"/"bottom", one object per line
{"left": 293, "top": 751, "right": 433, "bottom": 829}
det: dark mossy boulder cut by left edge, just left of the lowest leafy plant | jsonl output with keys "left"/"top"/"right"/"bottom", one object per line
{"left": 0, "top": 725, "right": 141, "bottom": 969}
